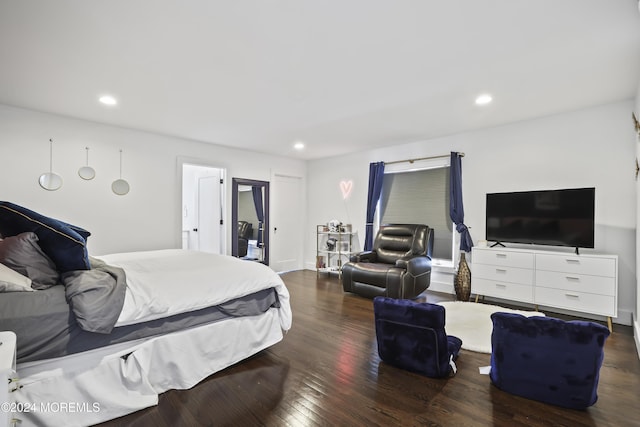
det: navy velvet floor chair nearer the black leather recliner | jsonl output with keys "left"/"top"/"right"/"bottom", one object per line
{"left": 373, "top": 297, "right": 462, "bottom": 378}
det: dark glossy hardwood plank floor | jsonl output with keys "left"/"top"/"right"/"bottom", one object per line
{"left": 101, "top": 271, "right": 640, "bottom": 427}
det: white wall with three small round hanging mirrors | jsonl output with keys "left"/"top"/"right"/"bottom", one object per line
{"left": 0, "top": 105, "right": 306, "bottom": 255}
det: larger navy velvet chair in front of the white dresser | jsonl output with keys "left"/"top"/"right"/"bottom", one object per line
{"left": 490, "top": 313, "right": 609, "bottom": 409}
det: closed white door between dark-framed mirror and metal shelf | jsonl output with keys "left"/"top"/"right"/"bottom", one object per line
{"left": 269, "top": 175, "right": 304, "bottom": 272}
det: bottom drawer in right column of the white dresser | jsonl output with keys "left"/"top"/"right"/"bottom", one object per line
{"left": 535, "top": 287, "right": 618, "bottom": 317}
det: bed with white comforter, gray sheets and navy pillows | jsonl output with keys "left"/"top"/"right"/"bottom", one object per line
{"left": 0, "top": 202, "right": 292, "bottom": 426}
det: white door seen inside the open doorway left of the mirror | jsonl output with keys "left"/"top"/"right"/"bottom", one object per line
{"left": 198, "top": 175, "right": 222, "bottom": 254}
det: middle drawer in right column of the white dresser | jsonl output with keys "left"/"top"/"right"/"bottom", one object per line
{"left": 536, "top": 270, "right": 616, "bottom": 296}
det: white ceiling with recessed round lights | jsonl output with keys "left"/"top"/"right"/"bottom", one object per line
{"left": 0, "top": 0, "right": 640, "bottom": 159}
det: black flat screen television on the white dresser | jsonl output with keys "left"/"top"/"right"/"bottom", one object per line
{"left": 486, "top": 188, "right": 595, "bottom": 249}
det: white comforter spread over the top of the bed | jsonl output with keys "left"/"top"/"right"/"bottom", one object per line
{"left": 96, "top": 249, "right": 291, "bottom": 330}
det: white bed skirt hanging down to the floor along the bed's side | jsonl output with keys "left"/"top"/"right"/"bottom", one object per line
{"left": 12, "top": 308, "right": 283, "bottom": 427}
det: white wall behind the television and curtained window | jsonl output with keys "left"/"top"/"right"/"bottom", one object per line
{"left": 305, "top": 100, "right": 636, "bottom": 324}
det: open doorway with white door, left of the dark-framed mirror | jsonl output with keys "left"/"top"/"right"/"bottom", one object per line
{"left": 182, "top": 163, "right": 225, "bottom": 254}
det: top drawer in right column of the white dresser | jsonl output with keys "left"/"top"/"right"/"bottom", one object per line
{"left": 536, "top": 254, "right": 617, "bottom": 277}
